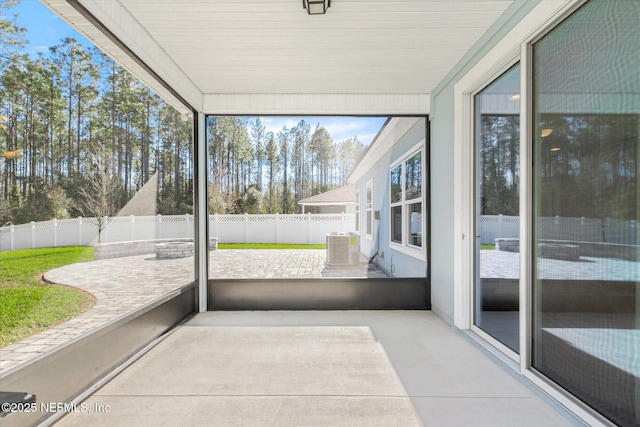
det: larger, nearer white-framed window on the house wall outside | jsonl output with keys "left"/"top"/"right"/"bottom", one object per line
{"left": 389, "top": 149, "right": 423, "bottom": 249}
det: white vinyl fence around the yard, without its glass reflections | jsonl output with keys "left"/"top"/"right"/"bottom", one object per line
{"left": 0, "top": 214, "right": 355, "bottom": 251}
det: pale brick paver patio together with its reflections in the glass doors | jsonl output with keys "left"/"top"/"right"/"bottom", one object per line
{"left": 0, "top": 249, "right": 640, "bottom": 373}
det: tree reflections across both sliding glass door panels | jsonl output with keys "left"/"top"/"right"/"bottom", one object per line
{"left": 478, "top": 114, "right": 640, "bottom": 220}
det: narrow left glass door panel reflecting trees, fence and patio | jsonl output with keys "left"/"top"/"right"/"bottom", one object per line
{"left": 474, "top": 64, "right": 520, "bottom": 353}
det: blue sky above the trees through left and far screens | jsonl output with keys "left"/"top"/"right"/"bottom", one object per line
{"left": 12, "top": 0, "right": 386, "bottom": 145}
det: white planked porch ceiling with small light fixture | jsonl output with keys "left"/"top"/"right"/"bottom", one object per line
{"left": 42, "top": 0, "right": 513, "bottom": 113}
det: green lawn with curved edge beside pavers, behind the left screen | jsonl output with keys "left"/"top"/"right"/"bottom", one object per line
{"left": 0, "top": 246, "right": 95, "bottom": 348}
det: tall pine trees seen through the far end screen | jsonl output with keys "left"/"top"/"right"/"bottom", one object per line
{"left": 207, "top": 117, "right": 364, "bottom": 213}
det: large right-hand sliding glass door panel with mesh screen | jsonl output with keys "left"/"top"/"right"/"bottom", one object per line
{"left": 531, "top": 0, "right": 640, "bottom": 426}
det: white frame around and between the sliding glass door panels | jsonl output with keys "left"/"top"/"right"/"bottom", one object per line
{"left": 453, "top": 0, "right": 606, "bottom": 426}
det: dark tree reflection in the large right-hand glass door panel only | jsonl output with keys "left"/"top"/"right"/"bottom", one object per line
{"left": 535, "top": 114, "right": 640, "bottom": 224}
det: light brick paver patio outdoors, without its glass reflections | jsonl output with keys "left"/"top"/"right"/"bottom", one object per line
{"left": 0, "top": 249, "right": 386, "bottom": 373}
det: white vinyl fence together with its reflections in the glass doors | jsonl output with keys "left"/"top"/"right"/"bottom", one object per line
{"left": 5, "top": 214, "right": 640, "bottom": 251}
